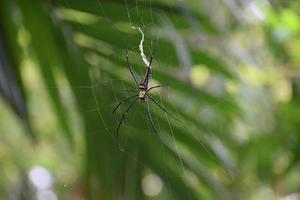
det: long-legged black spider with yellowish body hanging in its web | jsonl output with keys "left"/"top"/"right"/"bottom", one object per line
{"left": 113, "top": 48, "right": 176, "bottom": 149}
